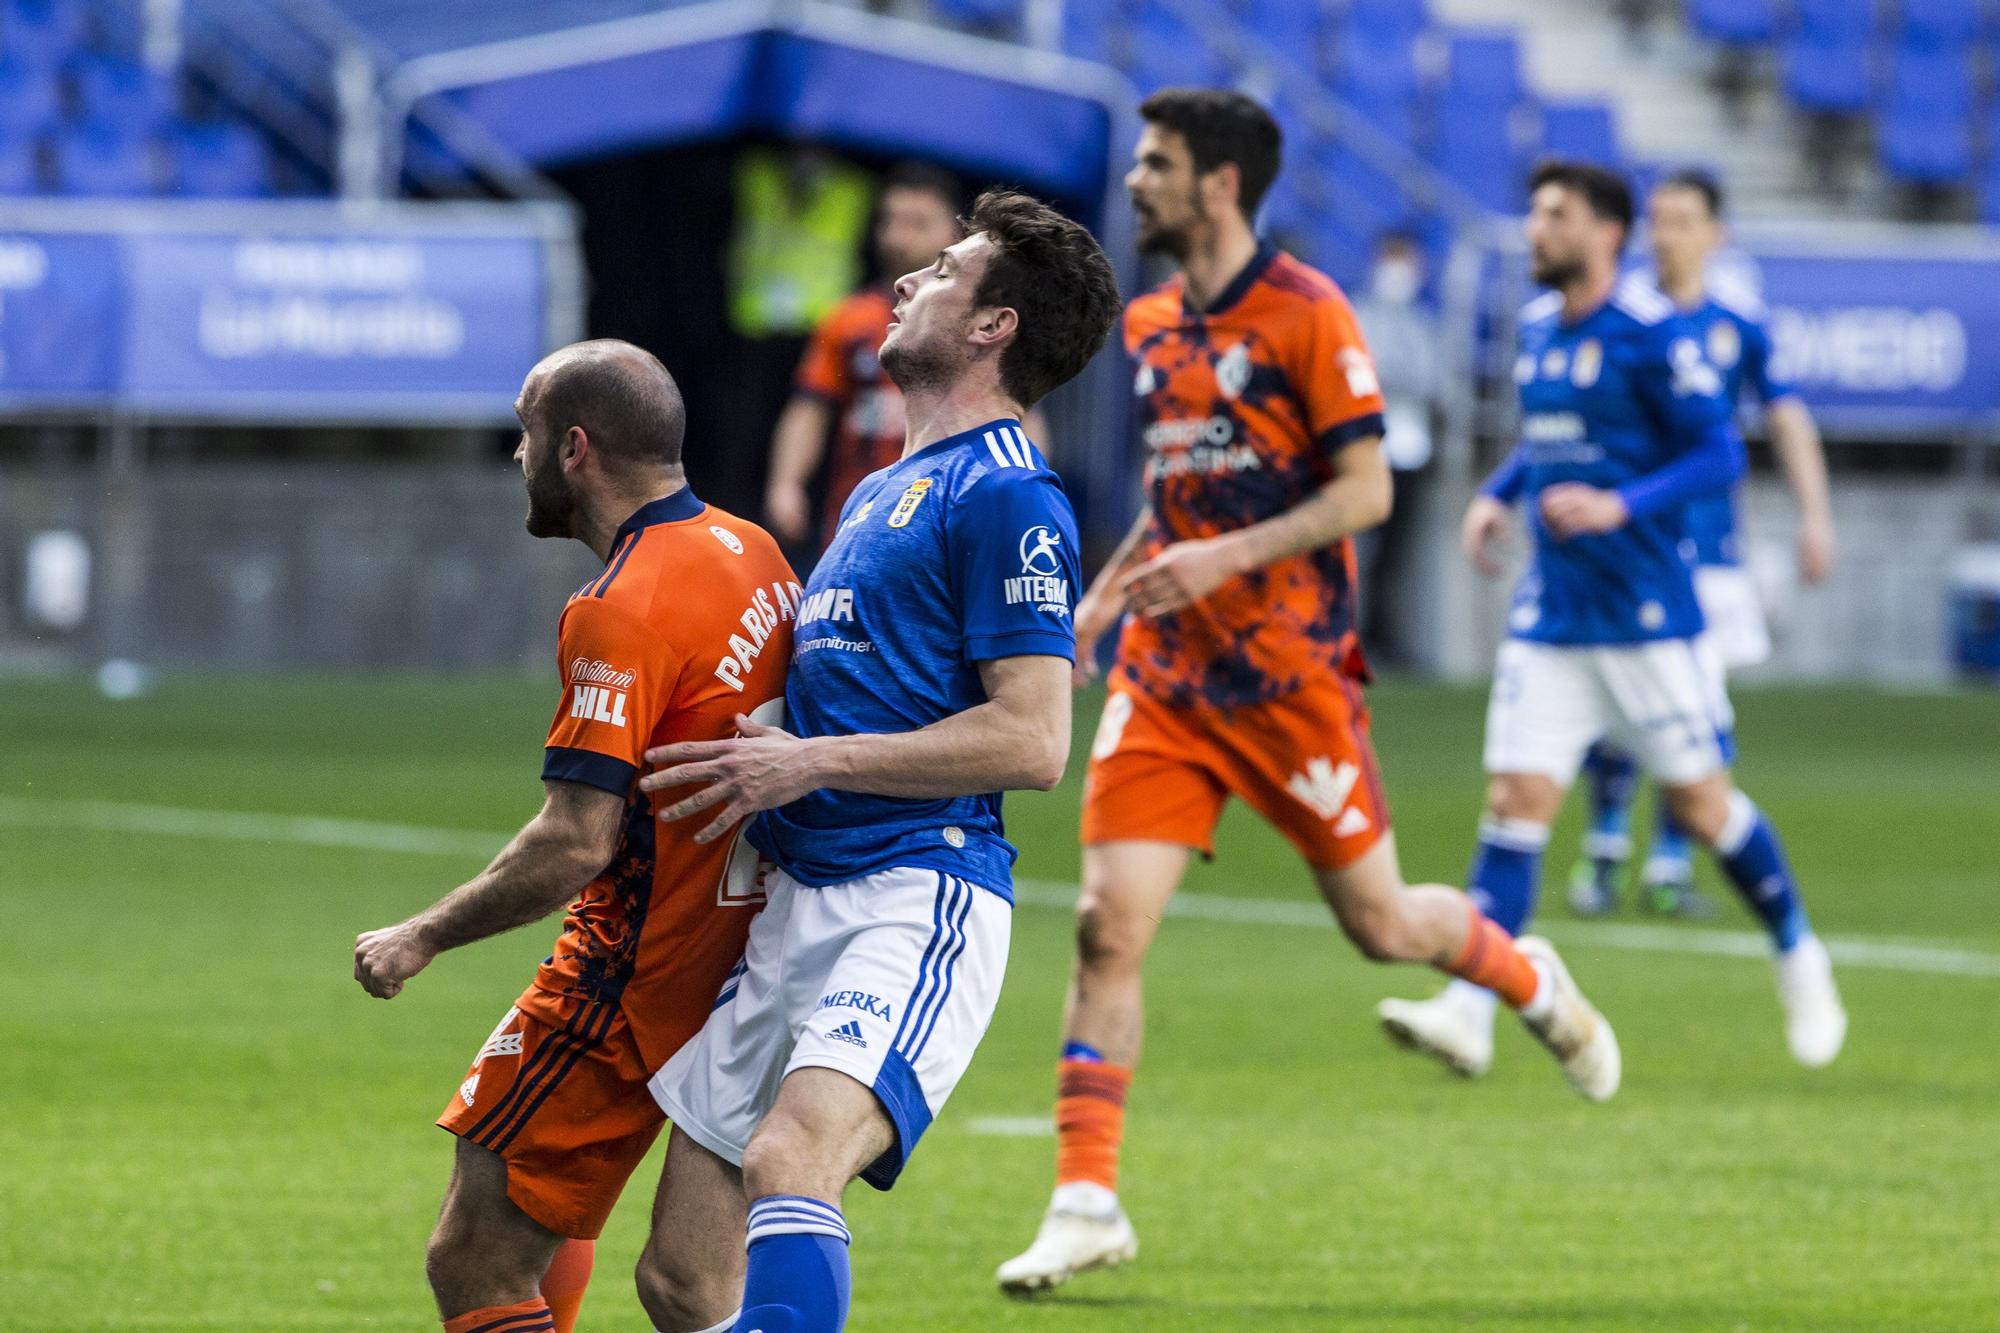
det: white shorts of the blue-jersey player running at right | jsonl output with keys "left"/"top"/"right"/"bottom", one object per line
{"left": 1486, "top": 638, "right": 1732, "bottom": 787}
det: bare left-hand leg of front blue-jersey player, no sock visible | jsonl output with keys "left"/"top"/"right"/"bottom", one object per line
{"left": 634, "top": 1129, "right": 746, "bottom": 1333}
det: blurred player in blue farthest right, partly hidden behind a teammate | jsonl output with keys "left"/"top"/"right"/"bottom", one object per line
{"left": 1570, "top": 172, "right": 1834, "bottom": 917}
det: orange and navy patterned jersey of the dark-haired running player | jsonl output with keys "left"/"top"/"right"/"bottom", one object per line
{"left": 1118, "top": 246, "right": 1382, "bottom": 709}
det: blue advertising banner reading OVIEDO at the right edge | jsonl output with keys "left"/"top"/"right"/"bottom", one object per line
{"left": 1750, "top": 239, "right": 2000, "bottom": 430}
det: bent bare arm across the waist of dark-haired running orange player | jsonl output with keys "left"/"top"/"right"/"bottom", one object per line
{"left": 1122, "top": 434, "right": 1394, "bottom": 616}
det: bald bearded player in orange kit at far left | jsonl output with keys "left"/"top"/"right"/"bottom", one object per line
{"left": 354, "top": 342, "right": 800, "bottom": 1333}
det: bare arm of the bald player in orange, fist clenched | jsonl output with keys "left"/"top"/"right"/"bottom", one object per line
{"left": 354, "top": 779, "right": 624, "bottom": 999}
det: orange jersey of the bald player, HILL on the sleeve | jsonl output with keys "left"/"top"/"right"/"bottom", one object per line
{"left": 520, "top": 490, "right": 800, "bottom": 1069}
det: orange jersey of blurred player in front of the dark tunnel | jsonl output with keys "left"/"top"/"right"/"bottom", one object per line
{"left": 794, "top": 288, "right": 902, "bottom": 546}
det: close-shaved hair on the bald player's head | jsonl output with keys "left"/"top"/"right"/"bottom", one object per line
{"left": 536, "top": 338, "right": 688, "bottom": 466}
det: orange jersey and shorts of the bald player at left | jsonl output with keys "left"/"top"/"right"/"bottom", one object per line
{"left": 438, "top": 490, "right": 800, "bottom": 1237}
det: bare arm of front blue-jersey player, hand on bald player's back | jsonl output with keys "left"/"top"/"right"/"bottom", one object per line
{"left": 640, "top": 656, "right": 1070, "bottom": 843}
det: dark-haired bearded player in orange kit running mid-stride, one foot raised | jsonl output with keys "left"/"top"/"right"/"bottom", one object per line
{"left": 998, "top": 88, "right": 1618, "bottom": 1293}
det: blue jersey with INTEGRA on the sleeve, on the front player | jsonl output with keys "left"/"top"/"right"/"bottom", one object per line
{"left": 750, "top": 420, "right": 1082, "bottom": 901}
